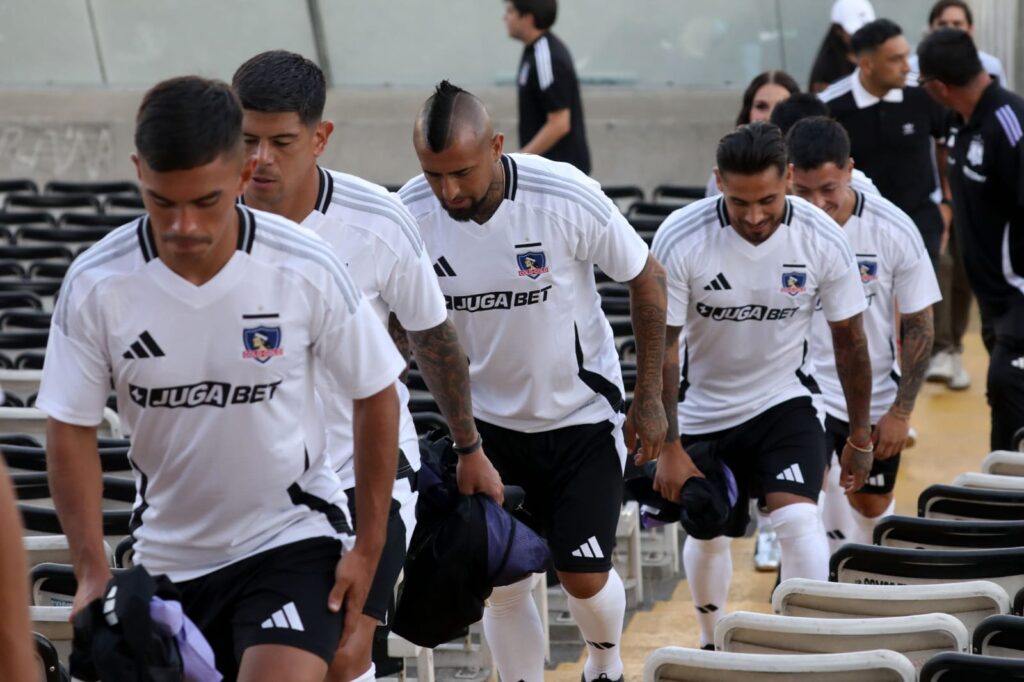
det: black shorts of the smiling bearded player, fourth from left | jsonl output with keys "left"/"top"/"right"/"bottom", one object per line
{"left": 681, "top": 397, "right": 825, "bottom": 538}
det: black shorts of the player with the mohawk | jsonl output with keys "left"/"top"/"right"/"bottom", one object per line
{"left": 476, "top": 421, "right": 624, "bottom": 573}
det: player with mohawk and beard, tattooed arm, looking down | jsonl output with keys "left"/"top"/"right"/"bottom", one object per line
{"left": 399, "top": 81, "right": 666, "bottom": 682}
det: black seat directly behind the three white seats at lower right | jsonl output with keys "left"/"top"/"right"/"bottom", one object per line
{"left": 828, "top": 544, "right": 1024, "bottom": 594}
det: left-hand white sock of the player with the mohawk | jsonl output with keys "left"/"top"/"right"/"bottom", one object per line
{"left": 483, "top": 576, "right": 544, "bottom": 682}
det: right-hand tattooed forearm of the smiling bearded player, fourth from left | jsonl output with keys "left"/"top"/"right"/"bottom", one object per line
{"left": 828, "top": 313, "right": 871, "bottom": 442}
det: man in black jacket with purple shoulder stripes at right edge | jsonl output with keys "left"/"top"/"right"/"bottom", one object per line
{"left": 918, "top": 29, "right": 1024, "bottom": 450}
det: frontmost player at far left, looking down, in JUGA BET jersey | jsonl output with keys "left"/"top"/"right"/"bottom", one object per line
{"left": 37, "top": 77, "right": 402, "bottom": 682}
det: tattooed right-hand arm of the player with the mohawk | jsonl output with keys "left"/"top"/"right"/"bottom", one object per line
{"left": 630, "top": 255, "right": 668, "bottom": 430}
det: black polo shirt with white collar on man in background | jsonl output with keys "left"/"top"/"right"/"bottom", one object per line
{"left": 819, "top": 72, "right": 947, "bottom": 220}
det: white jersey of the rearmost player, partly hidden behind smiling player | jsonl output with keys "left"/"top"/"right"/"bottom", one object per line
{"left": 811, "top": 191, "right": 942, "bottom": 424}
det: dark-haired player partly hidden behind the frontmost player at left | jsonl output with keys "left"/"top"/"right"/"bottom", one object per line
{"left": 232, "top": 50, "right": 503, "bottom": 680}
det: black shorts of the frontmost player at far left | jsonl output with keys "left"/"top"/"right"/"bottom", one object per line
{"left": 177, "top": 538, "right": 344, "bottom": 680}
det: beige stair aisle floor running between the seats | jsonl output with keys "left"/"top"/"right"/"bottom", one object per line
{"left": 545, "top": 333, "right": 989, "bottom": 682}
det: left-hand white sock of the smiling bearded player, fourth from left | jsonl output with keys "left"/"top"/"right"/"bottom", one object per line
{"left": 683, "top": 536, "right": 732, "bottom": 646}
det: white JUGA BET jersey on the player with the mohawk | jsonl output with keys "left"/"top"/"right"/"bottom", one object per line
{"left": 399, "top": 154, "right": 649, "bottom": 432}
